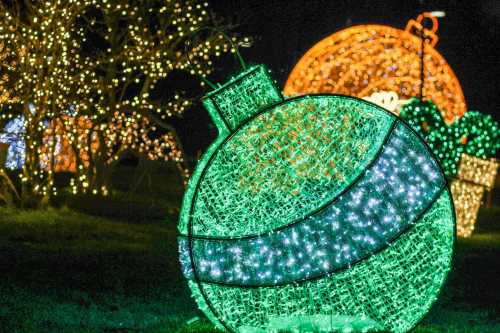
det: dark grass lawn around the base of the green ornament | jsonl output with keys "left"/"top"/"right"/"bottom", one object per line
{"left": 0, "top": 207, "right": 500, "bottom": 333}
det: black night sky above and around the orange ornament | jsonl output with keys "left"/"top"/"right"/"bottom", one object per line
{"left": 178, "top": 0, "right": 500, "bottom": 155}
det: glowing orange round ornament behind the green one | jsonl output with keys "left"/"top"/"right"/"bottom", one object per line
{"left": 284, "top": 13, "right": 466, "bottom": 123}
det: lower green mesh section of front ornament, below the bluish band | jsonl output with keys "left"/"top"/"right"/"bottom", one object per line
{"left": 189, "top": 190, "right": 454, "bottom": 332}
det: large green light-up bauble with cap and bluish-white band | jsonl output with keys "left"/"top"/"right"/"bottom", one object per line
{"left": 179, "top": 66, "right": 455, "bottom": 332}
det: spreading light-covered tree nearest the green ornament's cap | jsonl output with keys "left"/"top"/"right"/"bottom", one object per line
{"left": 65, "top": 0, "right": 245, "bottom": 193}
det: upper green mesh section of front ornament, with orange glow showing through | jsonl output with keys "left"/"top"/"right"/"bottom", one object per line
{"left": 186, "top": 96, "right": 394, "bottom": 237}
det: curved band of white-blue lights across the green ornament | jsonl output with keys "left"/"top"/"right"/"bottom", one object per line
{"left": 180, "top": 123, "right": 445, "bottom": 286}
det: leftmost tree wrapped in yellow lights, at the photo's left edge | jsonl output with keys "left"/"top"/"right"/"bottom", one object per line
{"left": 0, "top": 0, "right": 92, "bottom": 204}
